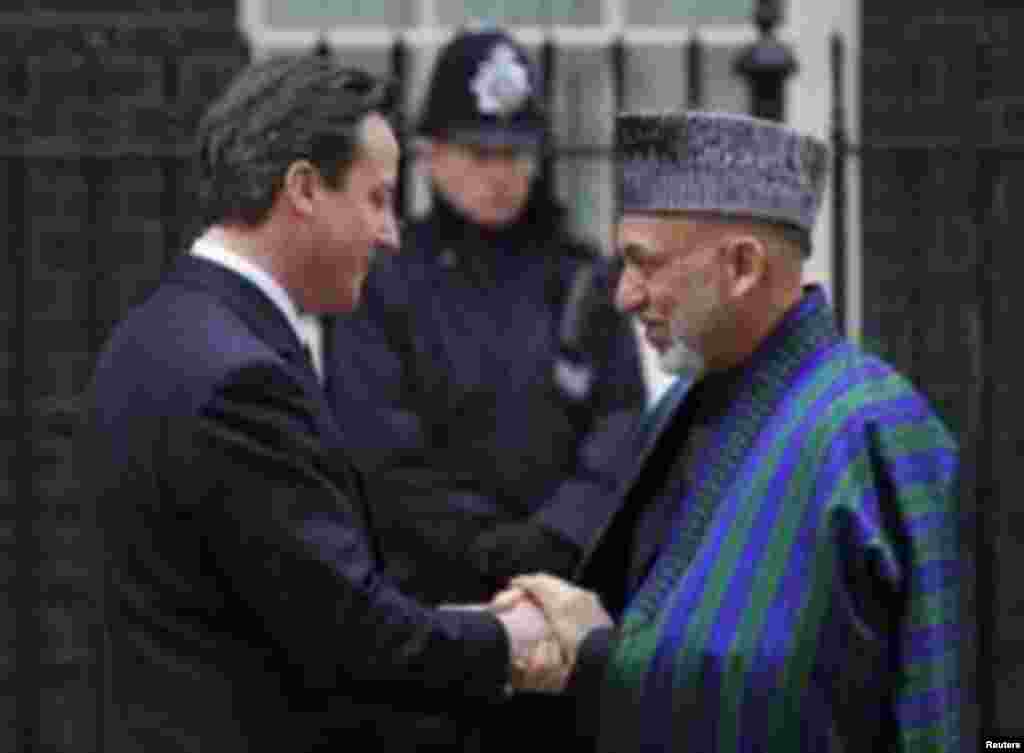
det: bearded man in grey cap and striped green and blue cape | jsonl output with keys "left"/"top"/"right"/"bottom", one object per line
{"left": 497, "top": 113, "right": 959, "bottom": 753}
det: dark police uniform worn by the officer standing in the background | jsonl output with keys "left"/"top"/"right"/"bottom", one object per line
{"left": 327, "top": 187, "right": 645, "bottom": 749}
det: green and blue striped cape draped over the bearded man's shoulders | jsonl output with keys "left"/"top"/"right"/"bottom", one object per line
{"left": 599, "top": 288, "right": 959, "bottom": 753}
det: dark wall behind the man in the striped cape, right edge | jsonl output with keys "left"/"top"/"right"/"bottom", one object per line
{"left": 860, "top": 0, "right": 1024, "bottom": 750}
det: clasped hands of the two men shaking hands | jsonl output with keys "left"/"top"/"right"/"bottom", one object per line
{"left": 454, "top": 574, "right": 612, "bottom": 693}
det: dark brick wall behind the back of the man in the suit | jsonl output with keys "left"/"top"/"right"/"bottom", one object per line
{"left": 0, "top": 0, "right": 247, "bottom": 753}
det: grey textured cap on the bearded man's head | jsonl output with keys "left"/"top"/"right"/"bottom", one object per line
{"left": 615, "top": 111, "right": 828, "bottom": 233}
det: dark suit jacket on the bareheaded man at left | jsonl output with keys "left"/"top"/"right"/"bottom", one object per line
{"left": 86, "top": 256, "right": 508, "bottom": 753}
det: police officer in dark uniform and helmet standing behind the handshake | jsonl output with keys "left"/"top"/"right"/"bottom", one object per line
{"left": 326, "top": 28, "right": 645, "bottom": 750}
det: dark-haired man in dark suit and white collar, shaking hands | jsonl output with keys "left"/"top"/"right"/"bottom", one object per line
{"left": 86, "top": 57, "right": 547, "bottom": 753}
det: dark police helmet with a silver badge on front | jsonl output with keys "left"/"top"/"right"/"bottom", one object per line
{"left": 419, "top": 27, "right": 547, "bottom": 149}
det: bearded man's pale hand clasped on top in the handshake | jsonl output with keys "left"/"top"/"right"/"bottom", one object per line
{"left": 511, "top": 574, "right": 613, "bottom": 677}
